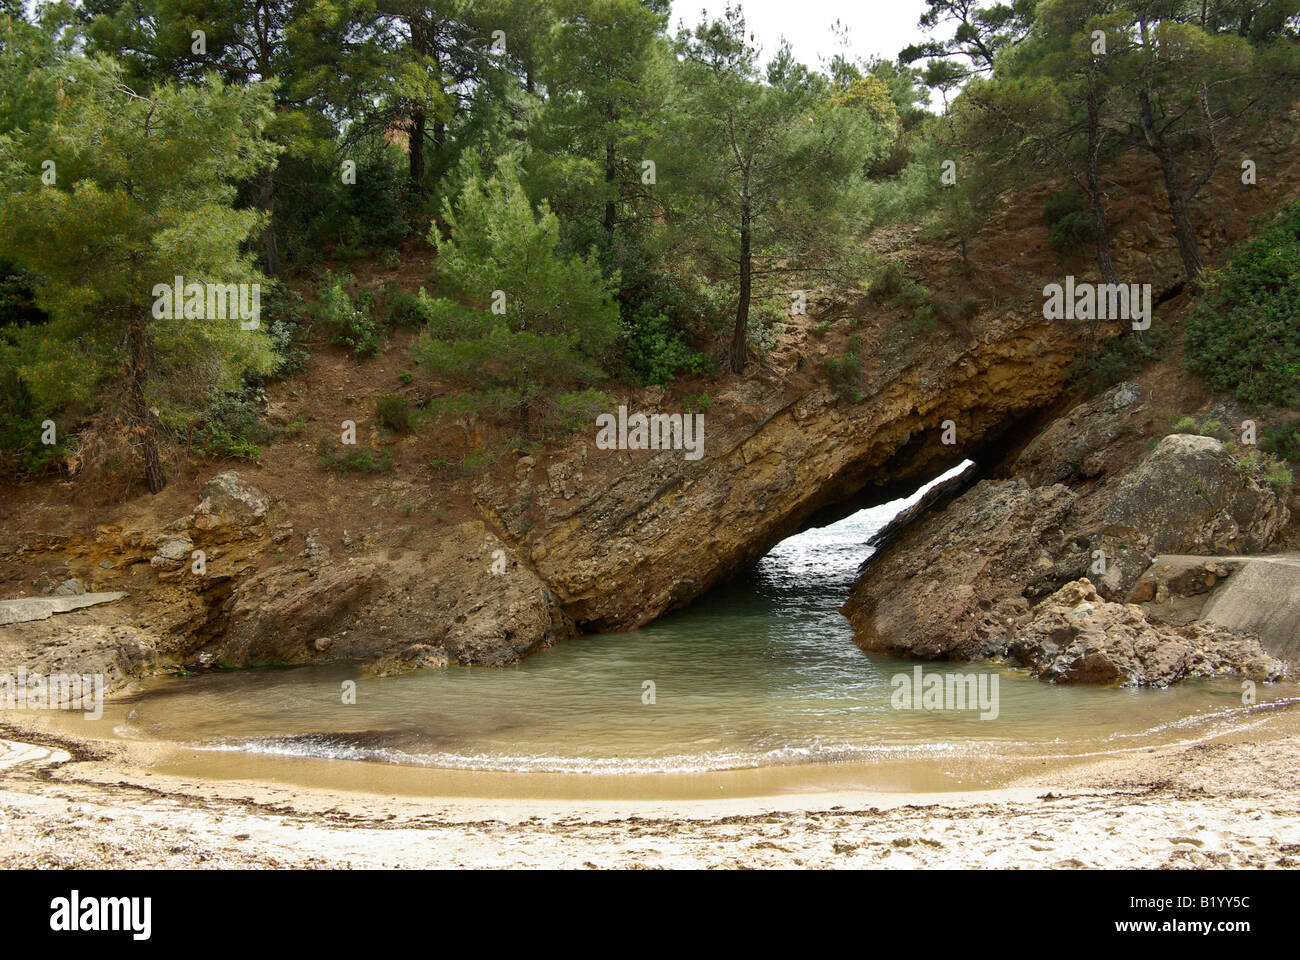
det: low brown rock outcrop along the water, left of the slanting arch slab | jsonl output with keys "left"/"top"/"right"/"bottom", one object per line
{"left": 0, "top": 472, "right": 573, "bottom": 678}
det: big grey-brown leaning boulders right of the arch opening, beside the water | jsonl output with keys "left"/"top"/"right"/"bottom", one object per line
{"left": 844, "top": 384, "right": 1290, "bottom": 684}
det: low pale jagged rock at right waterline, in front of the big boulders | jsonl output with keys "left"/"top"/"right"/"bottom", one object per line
{"left": 1008, "top": 579, "right": 1286, "bottom": 687}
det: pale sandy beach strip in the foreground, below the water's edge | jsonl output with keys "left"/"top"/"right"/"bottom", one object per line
{"left": 0, "top": 705, "right": 1300, "bottom": 869}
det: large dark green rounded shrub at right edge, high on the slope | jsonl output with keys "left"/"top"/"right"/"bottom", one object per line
{"left": 1186, "top": 203, "right": 1300, "bottom": 407}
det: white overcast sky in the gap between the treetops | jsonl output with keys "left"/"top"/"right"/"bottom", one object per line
{"left": 670, "top": 0, "right": 935, "bottom": 66}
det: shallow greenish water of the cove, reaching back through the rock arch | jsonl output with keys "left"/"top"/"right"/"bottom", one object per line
{"left": 101, "top": 465, "right": 1297, "bottom": 774}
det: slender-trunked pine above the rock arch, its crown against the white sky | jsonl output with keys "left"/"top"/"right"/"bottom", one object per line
{"left": 666, "top": 8, "right": 897, "bottom": 373}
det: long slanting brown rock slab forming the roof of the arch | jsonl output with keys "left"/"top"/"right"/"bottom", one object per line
{"left": 475, "top": 304, "right": 1102, "bottom": 631}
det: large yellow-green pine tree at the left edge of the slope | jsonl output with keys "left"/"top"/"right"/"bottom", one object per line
{"left": 0, "top": 57, "right": 274, "bottom": 493}
